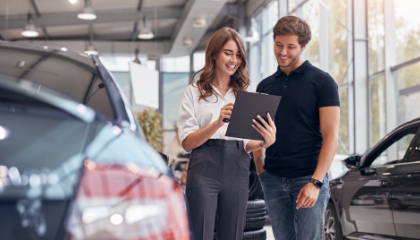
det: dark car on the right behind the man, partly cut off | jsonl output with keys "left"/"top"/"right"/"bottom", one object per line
{"left": 325, "top": 118, "right": 420, "bottom": 239}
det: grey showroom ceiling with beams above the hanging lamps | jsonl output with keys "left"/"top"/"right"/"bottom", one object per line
{"left": 0, "top": 0, "right": 264, "bottom": 56}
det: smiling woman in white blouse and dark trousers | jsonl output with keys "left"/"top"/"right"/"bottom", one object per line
{"left": 178, "top": 28, "right": 276, "bottom": 240}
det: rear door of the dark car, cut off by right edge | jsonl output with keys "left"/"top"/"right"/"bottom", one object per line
{"left": 389, "top": 127, "right": 420, "bottom": 239}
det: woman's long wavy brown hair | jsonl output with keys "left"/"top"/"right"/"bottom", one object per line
{"left": 191, "top": 27, "right": 249, "bottom": 100}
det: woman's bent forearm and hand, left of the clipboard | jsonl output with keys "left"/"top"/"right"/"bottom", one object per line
{"left": 182, "top": 103, "right": 233, "bottom": 152}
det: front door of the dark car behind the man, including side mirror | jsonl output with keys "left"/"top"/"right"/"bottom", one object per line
{"left": 343, "top": 125, "right": 416, "bottom": 239}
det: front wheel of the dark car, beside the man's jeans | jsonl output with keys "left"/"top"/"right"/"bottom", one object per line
{"left": 324, "top": 202, "right": 343, "bottom": 240}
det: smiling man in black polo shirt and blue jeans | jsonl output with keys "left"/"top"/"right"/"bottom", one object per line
{"left": 255, "top": 16, "right": 340, "bottom": 240}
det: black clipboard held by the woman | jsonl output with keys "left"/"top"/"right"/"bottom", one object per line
{"left": 226, "top": 92, "right": 281, "bottom": 140}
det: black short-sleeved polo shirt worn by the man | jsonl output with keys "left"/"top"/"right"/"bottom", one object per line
{"left": 257, "top": 61, "right": 340, "bottom": 178}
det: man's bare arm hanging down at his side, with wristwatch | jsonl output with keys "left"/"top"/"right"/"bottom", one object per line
{"left": 296, "top": 107, "right": 340, "bottom": 209}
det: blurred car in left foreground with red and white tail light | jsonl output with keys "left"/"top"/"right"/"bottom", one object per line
{"left": 0, "top": 42, "right": 190, "bottom": 240}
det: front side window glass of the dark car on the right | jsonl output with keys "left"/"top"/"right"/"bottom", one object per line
{"left": 371, "top": 128, "right": 417, "bottom": 167}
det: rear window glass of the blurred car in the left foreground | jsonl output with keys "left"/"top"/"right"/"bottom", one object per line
{"left": 0, "top": 44, "right": 115, "bottom": 119}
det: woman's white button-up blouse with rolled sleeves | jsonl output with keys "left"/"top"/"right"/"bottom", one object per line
{"left": 177, "top": 84, "right": 254, "bottom": 148}
